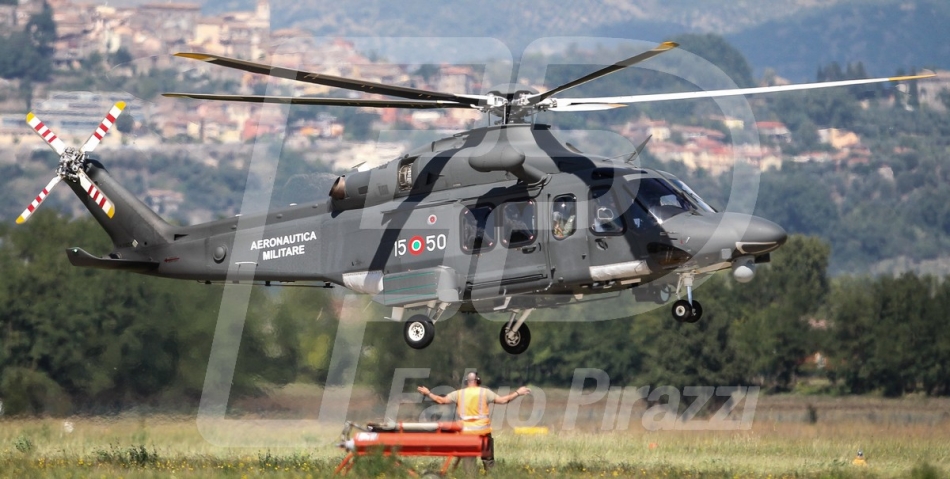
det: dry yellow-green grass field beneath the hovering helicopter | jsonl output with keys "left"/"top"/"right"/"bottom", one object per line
{"left": 0, "top": 395, "right": 950, "bottom": 478}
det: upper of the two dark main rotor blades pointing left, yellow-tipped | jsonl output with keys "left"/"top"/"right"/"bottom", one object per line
{"left": 175, "top": 53, "right": 484, "bottom": 105}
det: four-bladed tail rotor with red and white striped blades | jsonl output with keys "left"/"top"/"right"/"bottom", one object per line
{"left": 16, "top": 101, "right": 125, "bottom": 224}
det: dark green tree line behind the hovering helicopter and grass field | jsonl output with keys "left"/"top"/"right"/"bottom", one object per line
{"left": 0, "top": 211, "right": 950, "bottom": 414}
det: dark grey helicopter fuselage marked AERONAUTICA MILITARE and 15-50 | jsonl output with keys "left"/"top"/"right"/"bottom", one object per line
{"left": 82, "top": 124, "right": 785, "bottom": 307}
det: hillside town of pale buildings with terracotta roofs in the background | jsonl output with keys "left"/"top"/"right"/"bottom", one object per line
{"left": 0, "top": 0, "right": 950, "bottom": 175}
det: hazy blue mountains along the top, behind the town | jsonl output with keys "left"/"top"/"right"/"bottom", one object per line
{"left": 195, "top": 0, "right": 950, "bottom": 80}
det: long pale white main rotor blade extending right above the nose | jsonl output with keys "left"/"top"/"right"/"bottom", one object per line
{"left": 549, "top": 73, "right": 936, "bottom": 111}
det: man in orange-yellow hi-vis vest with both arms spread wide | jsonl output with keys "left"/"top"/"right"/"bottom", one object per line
{"left": 417, "top": 372, "right": 531, "bottom": 471}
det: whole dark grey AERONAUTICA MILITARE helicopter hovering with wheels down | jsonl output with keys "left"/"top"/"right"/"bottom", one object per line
{"left": 17, "top": 42, "right": 933, "bottom": 354}
